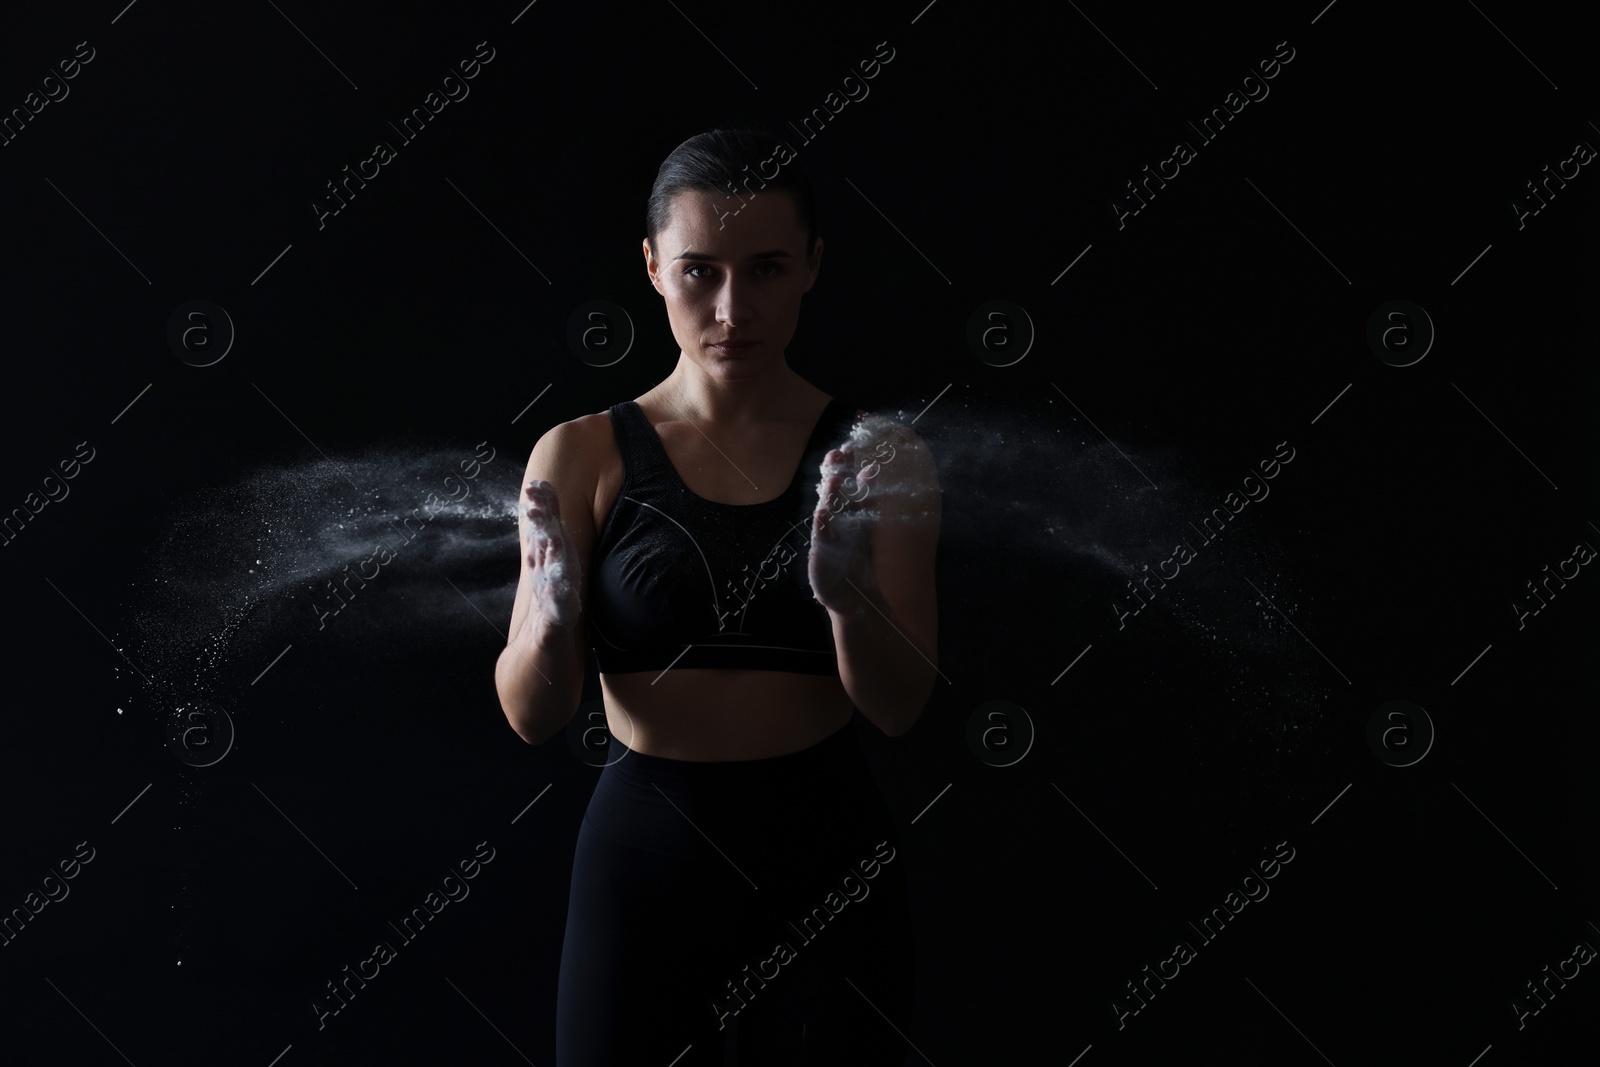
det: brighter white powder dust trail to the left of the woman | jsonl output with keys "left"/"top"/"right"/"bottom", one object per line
{"left": 118, "top": 446, "right": 523, "bottom": 755}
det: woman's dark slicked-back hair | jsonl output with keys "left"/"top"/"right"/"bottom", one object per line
{"left": 645, "top": 128, "right": 816, "bottom": 265}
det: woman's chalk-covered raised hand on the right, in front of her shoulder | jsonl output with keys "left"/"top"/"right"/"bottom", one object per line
{"left": 808, "top": 443, "right": 878, "bottom": 611}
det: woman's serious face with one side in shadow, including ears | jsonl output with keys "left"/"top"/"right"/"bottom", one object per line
{"left": 645, "top": 190, "right": 822, "bottom": 379}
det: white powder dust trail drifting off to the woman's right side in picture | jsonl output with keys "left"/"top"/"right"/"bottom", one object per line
{"left": 844, "top": 388, "right": 1344, "bottom": 753}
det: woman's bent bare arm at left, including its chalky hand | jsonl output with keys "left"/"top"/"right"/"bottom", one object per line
{"left": 494, "top": 421, "right": 595, "bottom": 744}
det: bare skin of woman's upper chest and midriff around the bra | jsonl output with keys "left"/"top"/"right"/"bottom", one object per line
{"left": 584, "top": 389, "right": 853, "bottom": 760}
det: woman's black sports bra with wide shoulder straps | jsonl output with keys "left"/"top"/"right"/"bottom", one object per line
{"left": 584, "top": 397, "right": 856, "bottom": 675}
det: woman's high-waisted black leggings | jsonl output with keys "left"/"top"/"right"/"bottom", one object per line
{"left": 555, "top": 723, "right": 912, "bottom": 1067}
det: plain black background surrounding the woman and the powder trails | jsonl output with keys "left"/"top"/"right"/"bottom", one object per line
{"left": 0, "top": 0, "right": 1600, "bottom": 1067}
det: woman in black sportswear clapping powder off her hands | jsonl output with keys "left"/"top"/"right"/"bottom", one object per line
{"left": 494, "top": 130, "right": 939, "bottom": 1067}
